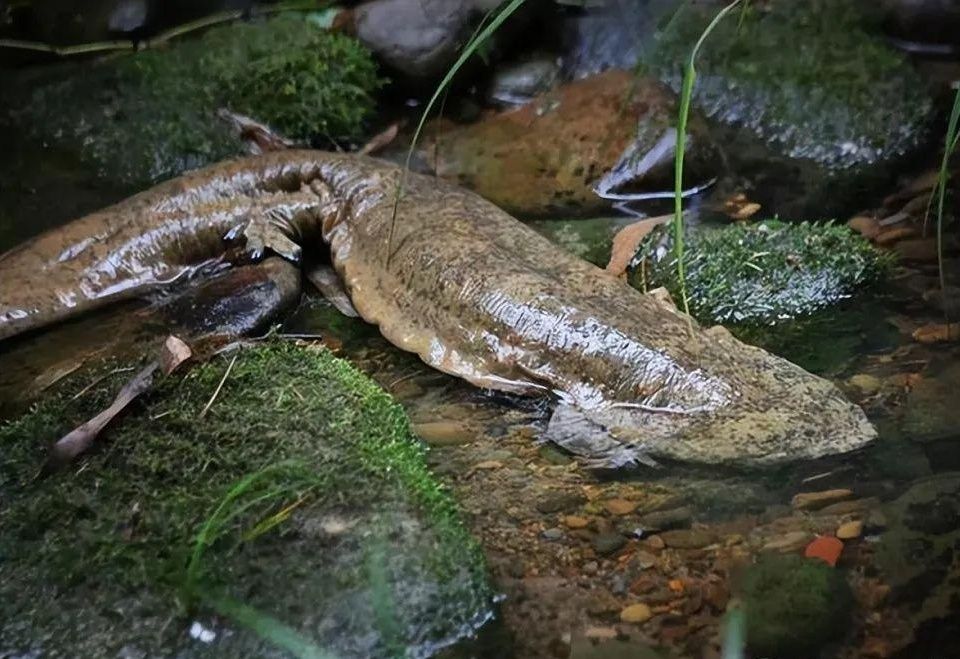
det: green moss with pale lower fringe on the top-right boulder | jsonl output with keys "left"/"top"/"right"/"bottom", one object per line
{"left": 648, "top": 0, "right": 932, "bottom": 173}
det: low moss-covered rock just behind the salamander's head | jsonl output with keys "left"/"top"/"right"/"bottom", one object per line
{"left": 630, "top": 220, "right": 889, "bottom": 324}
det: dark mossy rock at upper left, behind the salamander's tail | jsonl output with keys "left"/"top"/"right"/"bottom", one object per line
{"left": 4, "top": 14, "right": 381, "bottom": 185}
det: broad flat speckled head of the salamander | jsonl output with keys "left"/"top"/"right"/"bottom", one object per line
{"left": 547, "top": 328, "right": 877, "bottom": 468}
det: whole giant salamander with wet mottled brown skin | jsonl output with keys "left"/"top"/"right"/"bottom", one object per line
{"left": 0, "top": 151, "right": 875, "bottom": 464}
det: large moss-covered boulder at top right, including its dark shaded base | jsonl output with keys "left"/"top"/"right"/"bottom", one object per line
{"left": 645, "top": 0, "right": 933, "bottom": 218}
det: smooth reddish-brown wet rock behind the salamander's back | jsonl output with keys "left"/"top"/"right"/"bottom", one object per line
{"left": 419, "top": 70, "right": 719, "bottom": 216}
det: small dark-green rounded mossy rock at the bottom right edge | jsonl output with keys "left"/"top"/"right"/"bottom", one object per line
{"left": 739, "top": 554, "right": 853, "bottom": 659}
